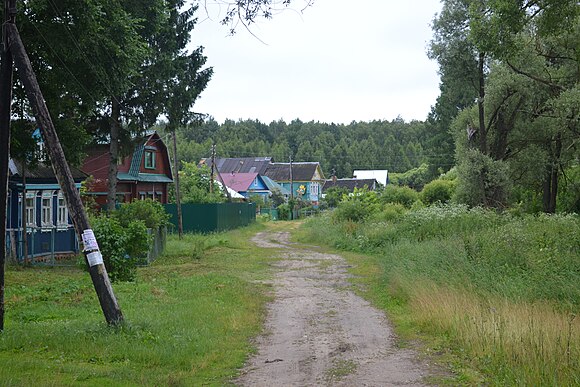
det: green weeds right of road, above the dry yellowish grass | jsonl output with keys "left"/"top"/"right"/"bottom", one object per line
{"left": 304, "top": 205, "right": 580, "bottom": 313}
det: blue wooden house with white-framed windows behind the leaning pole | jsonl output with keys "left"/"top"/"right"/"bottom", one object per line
{"left": 6, "top": 159, "right": 86, "bottom": 264}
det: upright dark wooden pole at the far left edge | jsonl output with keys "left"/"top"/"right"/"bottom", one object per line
{"left": 0, "top": 0, "right": 16, "bottom": 331}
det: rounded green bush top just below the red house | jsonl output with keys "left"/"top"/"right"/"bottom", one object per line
{"left": 111, "top": 199, "right": 169, "bottom": 230}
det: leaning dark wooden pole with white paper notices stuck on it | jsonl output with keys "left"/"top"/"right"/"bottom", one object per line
{"left": 6, "top": 24, "right": 123, "bottom": 325}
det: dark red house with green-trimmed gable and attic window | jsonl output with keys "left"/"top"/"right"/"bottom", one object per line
{"left": 81, "top": 132, "right": 173, "bottom": 206}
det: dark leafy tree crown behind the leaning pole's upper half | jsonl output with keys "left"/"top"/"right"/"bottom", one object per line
{"left": 14, "top": 0, "right": 147, "bottom": 164}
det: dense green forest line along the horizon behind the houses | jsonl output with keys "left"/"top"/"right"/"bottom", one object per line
{"left": 168, "top": 118, "right": 454, "bottom": 178}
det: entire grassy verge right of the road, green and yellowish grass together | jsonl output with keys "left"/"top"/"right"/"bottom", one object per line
{"left": 298, "top": 207, "right": 580, "bottom": 386}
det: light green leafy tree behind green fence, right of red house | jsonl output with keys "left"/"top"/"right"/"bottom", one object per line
{"left": 179, "top": 161, "right": 226, "bottom": 203}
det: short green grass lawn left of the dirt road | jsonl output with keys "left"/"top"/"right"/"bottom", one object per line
{"left": 0, "top": 224, "right": 280, "bottom": 386}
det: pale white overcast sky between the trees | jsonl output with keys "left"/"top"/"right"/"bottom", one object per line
{"left": 192, "top": 0, "right": 441, "bottom": 123}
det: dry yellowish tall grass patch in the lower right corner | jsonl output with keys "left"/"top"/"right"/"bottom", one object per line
{"left": 409, "top": 283, "right": 580, "bottom": 386}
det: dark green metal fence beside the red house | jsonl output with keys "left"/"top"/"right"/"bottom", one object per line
{"left": 164, "top": 203, "right": 256, "bottom": 233}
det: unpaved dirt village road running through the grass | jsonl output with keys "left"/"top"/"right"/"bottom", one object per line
{"left": 236, "top": 232, "right": 428, "bottom": 386}
